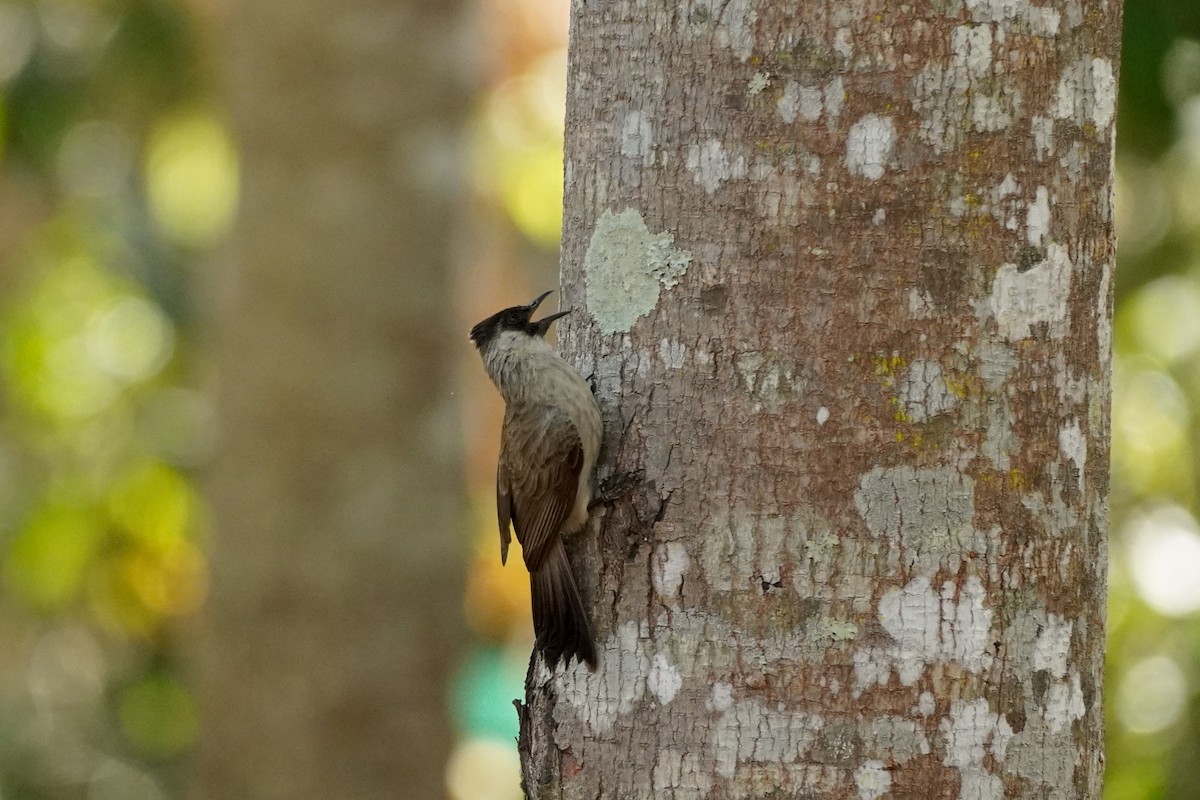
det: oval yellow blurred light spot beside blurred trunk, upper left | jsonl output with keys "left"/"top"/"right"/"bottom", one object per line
{"left": 144, "top": 109, "right": 238, "bottom": 247}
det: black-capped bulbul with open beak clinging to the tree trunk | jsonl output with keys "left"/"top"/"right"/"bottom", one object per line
{"left": 470, "top": 291, "right": 604, "bottom": 669}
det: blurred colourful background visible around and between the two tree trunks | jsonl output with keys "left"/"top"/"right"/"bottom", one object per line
{"left": 0, "top": 0, "right": 1200, "bottom": 800}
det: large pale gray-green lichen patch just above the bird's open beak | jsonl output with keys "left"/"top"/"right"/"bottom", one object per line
{"left": 583, "top": 209, "right": 692, "bottom": 333}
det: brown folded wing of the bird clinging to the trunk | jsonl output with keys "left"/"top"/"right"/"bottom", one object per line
{"left": 497, "top": 403, "right": 583, "bottom": 572}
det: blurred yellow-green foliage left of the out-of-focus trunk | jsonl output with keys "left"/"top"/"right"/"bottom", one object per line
{"left": 0, "top": 0, "right": 213, "bottom": 799}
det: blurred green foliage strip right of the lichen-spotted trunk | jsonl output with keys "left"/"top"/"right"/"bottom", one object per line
{"left": 1105, "top": 0, "right": 1200, "bottom": 800}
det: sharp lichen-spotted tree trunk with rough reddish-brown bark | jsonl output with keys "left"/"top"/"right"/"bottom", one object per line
{"left": 522, "top": 0, "right": 1121, "bottom": 800}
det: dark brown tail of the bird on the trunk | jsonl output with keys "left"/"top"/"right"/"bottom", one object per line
{"left": 529, "top": 544, "right": 596, "bottom": 669}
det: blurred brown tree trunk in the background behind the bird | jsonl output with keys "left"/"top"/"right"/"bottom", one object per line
{"left": 196, "top": 0, "right": 468, "bottom": 800}
